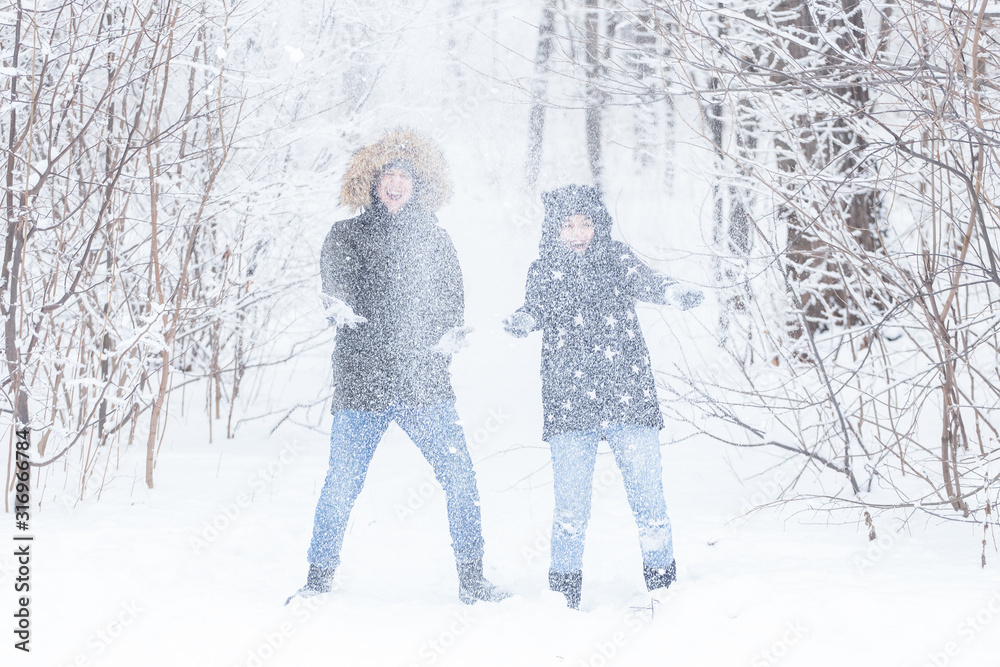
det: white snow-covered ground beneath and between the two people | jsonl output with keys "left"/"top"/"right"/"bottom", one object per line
{"left": 11, "top": 197, "right": 1000, "bottom": 667}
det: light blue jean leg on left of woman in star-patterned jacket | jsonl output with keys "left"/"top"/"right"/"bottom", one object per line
{"left": 549, "top": 430, "right": 600, "bottom": 574}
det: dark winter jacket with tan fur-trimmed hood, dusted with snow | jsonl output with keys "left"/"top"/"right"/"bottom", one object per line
{"left": 320, "top": 127, "right": 465, "bottom": 412}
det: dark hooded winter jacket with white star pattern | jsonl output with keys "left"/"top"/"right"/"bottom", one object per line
{"left": 521, "top": 186, "right": 673, "bottom": 440}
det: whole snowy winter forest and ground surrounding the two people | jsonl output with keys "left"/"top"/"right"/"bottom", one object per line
{"left": 0, "top": 0, "right": 1000, "bottom": 667}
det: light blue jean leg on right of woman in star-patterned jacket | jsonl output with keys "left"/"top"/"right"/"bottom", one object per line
{"left": 607, "top": 426, "right": 674, "bottom": 583}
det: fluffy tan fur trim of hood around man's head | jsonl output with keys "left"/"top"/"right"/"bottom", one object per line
{"left": 340, "top": 128, "right": 451, "bottom": 212}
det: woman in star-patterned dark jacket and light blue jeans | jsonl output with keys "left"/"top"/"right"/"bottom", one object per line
{"left": 504, "top": 185, "right": 702, "bottom": 609}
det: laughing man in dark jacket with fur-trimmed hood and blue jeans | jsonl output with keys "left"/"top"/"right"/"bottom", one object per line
{"left": 289, "top": 130, "right": 506, "bottom": 604}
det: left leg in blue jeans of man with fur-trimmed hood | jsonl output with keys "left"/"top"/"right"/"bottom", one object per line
{"left": 307, "top": 410, "right": 389, "bottom": 571}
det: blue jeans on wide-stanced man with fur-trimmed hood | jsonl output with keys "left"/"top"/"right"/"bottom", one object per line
{"left": 307, "top": 401, "right": 483, "bottom": 568}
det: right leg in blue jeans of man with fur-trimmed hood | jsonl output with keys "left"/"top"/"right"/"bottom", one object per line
{"left": 393, "top": 401, "right": 483, "bottom": 563}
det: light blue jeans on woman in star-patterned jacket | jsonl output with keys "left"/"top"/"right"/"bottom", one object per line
{"left": 549, "top": 424, "right": 674, "bottom": 574}
